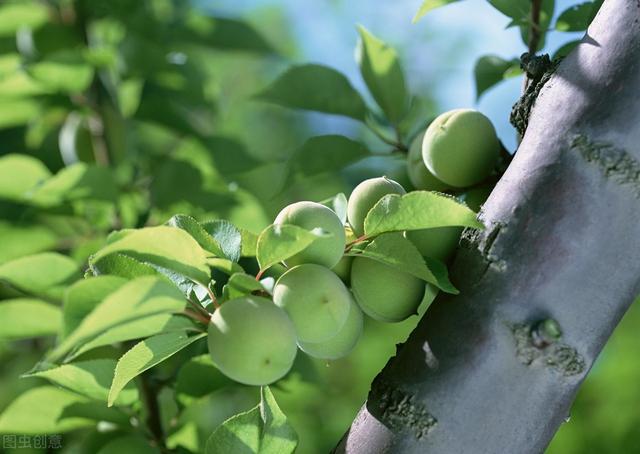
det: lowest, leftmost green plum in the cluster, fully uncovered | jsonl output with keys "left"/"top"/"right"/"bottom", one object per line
{"left": 208, "top": 296, "right": 297, "bottom": 386}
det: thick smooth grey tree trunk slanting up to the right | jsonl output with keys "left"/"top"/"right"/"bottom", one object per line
{"left": 337, "top": 0, "right": 640, "bottom": 454}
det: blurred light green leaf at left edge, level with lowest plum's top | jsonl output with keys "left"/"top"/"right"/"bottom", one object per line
{"left": 0, "top": 298, "right": 62, "bottom": 339}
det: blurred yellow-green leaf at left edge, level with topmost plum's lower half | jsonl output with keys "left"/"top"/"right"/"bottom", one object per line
{"left": 0, "top": 154, "right": 51, "bottom": 201}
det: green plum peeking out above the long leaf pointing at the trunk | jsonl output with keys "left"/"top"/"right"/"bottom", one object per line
{"left": 347, "top": 177, "right": 406, "bottom": 236}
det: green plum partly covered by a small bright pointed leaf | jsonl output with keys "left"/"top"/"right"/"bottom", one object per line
{"left": 274, "top": 202, "right": 346, "bottom": 268}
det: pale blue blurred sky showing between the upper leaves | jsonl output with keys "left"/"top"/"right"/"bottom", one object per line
{"left": 205, "top": 0, "right": 580, "bottom": 149}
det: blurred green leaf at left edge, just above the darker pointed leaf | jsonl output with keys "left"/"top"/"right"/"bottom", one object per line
{"left": 0, "top": 222, "right": 58, "bottom": 264}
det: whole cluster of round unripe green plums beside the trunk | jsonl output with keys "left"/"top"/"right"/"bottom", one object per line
{"left": 209, "top": 110, "right": 499, "bottom": 385}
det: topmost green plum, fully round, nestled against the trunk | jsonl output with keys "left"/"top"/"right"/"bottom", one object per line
{"left": 422, "top": 109, "right": 500, "bottom": 188}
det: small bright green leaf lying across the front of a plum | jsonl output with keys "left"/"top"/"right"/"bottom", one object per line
{"left": 256, "top": 224, "right": 327, "bottom": 270}
